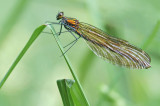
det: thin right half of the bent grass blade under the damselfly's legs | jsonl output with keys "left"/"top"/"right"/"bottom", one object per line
{"left": 48, "top": 24, "right": 89, "bottom": 106}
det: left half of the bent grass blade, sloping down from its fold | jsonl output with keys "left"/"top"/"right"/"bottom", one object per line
{"left": 0, "top": 25, "right": 46, "bottom": 88}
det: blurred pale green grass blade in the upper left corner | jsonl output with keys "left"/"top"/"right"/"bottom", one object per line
{"left": 0, "top": 0, "right": 30, "bottom": 45}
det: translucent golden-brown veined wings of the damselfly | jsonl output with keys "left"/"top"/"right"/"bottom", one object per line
{"left": 77, "top": 23, "right": 151, "bottom": 69}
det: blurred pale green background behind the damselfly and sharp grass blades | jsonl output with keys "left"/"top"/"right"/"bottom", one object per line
{"left": 0, "top": 0, "right": 160, "bottom": 106}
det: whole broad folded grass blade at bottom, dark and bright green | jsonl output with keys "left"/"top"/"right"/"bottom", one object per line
{"left": 57, "top": 79, "right": 90, "bottom": 106}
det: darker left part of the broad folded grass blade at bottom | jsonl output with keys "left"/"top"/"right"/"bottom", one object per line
{"left": 57, "top": 79, "right": 75, "bottom": 106}
